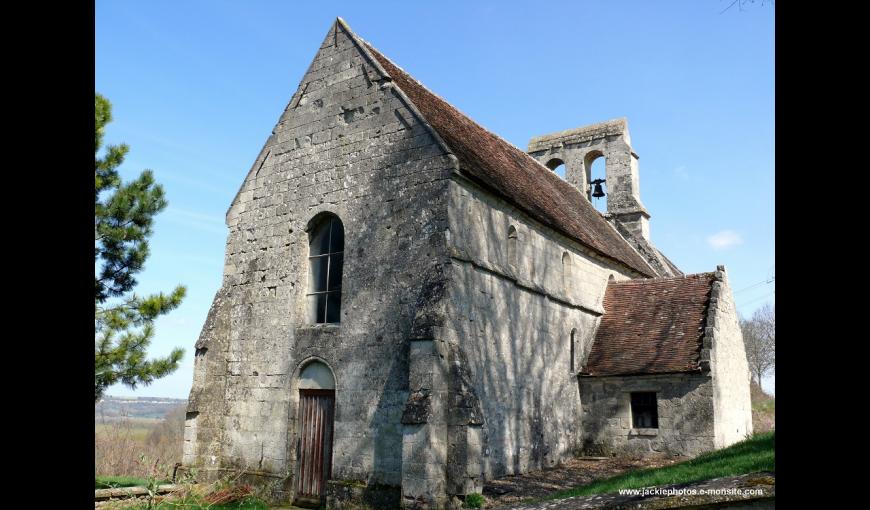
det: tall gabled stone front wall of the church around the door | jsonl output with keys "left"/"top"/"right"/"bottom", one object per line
{"left": 184, "top": 22, "right": 453, "bottom": 499}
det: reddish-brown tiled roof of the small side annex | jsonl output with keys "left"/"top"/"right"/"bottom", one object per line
{"left": 581, "top": 273, "right": 715, "bottom": 376}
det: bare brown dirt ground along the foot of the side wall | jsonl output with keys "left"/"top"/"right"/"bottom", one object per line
{"left": 483, "top": 455, "right": 685, "bottom": 508}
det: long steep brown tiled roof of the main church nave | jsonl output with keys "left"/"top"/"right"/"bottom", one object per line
{"left": 340, "top": 20, "right": 656, "bottom": 276}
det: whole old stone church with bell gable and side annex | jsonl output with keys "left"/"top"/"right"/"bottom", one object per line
{"left": 184, "top": 19, "right": 752, "bottom": 508}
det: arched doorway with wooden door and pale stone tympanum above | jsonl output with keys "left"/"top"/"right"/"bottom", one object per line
{"left": 294, "top": 361, "right": 335, "bottom": 507}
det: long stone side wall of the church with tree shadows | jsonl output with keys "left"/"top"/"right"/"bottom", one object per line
{"left": 440, "top": 177, "right": 632, "bottom": 488}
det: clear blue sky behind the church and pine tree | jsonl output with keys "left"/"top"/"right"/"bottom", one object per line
{"left": 94, "top": 0, "right": 775, "bottom": 398}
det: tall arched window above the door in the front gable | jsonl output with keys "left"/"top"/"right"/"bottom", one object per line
{"left": 308, "top": 214, "right": 344, "bottom": 324}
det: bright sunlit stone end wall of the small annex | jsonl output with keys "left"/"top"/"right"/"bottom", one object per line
{"left": 701, "top": 266, "right": 752, "bottom": 448}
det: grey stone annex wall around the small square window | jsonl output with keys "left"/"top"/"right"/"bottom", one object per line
{"left": 580, "top": 374, "right": 714, "bottom": 456}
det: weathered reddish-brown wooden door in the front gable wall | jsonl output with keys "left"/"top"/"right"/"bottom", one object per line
{"left": 296, "top": 390, "right": 335, "bottom": 506}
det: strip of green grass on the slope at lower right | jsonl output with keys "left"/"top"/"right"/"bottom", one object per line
{"left": 542, "top": 431, "right": 776, "bottom": 500}
